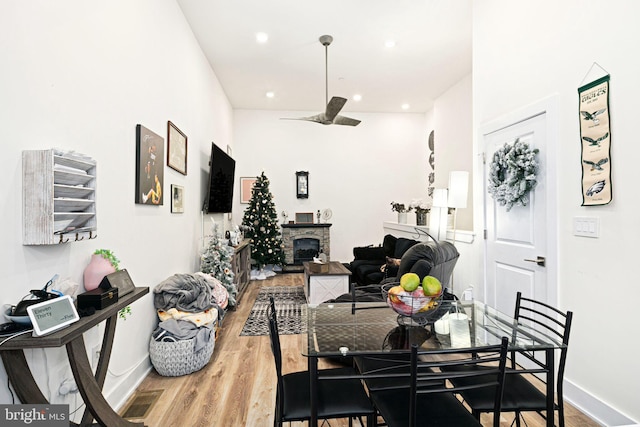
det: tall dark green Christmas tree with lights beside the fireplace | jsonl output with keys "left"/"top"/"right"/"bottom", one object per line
{"left": 242, "top": 172, "right": 285, "bottom": 269}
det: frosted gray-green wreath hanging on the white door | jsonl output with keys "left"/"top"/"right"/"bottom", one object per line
{"left": 488, "top": 139, "right": 539, "bottom": 212}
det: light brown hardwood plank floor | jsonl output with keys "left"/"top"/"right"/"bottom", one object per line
{"left": 123, "top": 274, "right": 599, "bottom": 427}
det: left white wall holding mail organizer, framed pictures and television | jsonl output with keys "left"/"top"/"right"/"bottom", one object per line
{"left": 0, "top": 0, "right": 233, "bottom": 410}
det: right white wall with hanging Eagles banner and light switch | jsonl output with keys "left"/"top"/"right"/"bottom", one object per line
{"left": 473, "top": 0, "right": 640, "bottom": 425}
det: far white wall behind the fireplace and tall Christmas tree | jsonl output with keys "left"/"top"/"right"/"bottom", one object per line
{"left": 234, "top": 110, "right": 430, "bottom": 262}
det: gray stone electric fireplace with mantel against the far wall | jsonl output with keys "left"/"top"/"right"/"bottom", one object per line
{"left": 282, "top": 224, "right": 331, "bottom": 265}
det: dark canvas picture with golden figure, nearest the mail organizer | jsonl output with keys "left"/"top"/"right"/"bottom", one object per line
{"left": 135, "top": 124, "right": 164, "bottom": 206}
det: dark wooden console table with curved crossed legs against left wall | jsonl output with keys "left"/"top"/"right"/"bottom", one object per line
{"left": 0, "top": 287, "right": 149, "bottom": 427}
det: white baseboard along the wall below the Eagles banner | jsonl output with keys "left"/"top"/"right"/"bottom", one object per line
{"left": 564, "top": 379, "right": 638, "bottom": 427}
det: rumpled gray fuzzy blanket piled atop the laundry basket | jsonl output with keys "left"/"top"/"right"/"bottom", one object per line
{"left": 153, "top": 274, "right": 216, "bottom": 313}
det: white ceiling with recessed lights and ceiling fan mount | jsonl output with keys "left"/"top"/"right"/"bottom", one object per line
{"left": 177, "top": 0, "right": 471, "bottom": 112}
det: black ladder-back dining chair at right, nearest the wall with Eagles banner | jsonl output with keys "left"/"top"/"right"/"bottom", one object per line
{"left": 444, "top": 292, "right": 573, "bottom": 427}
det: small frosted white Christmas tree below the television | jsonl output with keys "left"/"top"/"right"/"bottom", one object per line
{"left": 200, "top": 223, "right": 238, "bottom": 307}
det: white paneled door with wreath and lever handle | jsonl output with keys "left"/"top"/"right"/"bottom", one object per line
{"left": 481, "top": 98, "right": 556, "bottom": 314}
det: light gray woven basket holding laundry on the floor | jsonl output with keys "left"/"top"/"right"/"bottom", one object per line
{"left": 149, "top": 335, "right": 216, "bottom": 377}
